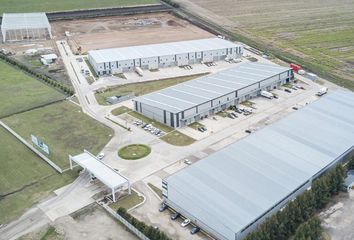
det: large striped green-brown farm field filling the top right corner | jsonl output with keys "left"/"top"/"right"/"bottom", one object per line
{"left": 177, "top": 0, "right": 354, "bottom": 90}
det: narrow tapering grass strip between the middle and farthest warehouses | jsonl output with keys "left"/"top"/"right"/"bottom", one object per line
{"left": 96, "top": 73, "right": 206, "bottom": 105}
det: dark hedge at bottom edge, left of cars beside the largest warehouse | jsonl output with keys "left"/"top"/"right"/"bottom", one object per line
{"left": 117, "top": 207, "right": 171, "bottom": 240}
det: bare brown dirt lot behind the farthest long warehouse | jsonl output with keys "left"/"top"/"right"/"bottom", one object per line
{"left": 51, "top": 13, "right": 213, "bottom": 53}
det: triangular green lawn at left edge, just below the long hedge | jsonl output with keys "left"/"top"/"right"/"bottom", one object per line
{"left": 0, "top": 61, "right": 65, "bottom": 118}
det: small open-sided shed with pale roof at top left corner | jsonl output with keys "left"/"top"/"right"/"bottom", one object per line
{"left": 1, "top": 13, "right": 52, "bottom": 42}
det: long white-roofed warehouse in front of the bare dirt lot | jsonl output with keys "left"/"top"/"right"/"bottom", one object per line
{"left": 88, "top": 38, "right": 243, "bottom": 75}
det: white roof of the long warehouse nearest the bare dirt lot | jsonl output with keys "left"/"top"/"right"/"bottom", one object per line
{"left": 88, "top": 38, "right": 241, "bottom": 63}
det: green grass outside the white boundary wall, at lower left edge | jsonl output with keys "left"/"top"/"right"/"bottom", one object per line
{"left": 0, "top": 127, "right": 76, "bottom": 224}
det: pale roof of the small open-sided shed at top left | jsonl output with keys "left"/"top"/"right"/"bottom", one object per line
{"left": 1, "top": 12, "right": 50, "bottom": 31}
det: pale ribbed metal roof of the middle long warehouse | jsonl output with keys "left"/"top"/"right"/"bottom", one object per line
{"left": 134, "top": 63, "right": 290, "bottom": 113}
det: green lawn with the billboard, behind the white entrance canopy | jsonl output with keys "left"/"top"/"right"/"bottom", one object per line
{"left": 3, "top": 101, "right": 113, "bottom": 169}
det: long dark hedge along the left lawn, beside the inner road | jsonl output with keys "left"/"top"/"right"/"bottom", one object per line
{"left": 0, "top": 53, "right": 75, "bottom": 96}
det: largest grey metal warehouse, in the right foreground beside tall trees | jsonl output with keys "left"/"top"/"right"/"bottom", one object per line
{"left": 162, "top": 90, "right": 354, "bottom": 240}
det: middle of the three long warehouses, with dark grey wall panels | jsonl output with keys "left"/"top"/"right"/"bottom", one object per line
{"left": 134, "top": 63, "right": 294, "bottom": 127}
